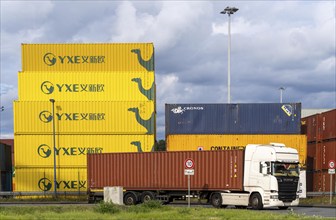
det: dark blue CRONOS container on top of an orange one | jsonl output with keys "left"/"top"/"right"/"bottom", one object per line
{"left": 165, "top": 103, "right": 301, "bottom": 136}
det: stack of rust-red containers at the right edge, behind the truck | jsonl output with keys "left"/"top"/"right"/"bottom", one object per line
{"left": 301, "top": 109, "right": 336, "bottom": 192}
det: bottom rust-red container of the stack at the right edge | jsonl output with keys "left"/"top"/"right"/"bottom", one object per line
{"left": 313, "top": 171, "right": 336, "bottom": 192}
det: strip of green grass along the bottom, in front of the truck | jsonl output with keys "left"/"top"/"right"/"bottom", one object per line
{"left": 0, "top": 201, "right": 328, "bottom": 220}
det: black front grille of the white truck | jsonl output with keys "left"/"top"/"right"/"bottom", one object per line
{"left": 277, "top": 177, "right": 299, "bottom": 202}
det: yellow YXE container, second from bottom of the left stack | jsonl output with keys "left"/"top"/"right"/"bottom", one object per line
{"left": 14, "top": 135, "right": 155, "bottom": 167}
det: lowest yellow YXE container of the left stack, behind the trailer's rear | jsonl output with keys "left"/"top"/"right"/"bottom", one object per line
{"left": 13, "top": 167, "right": 88, "bottom": 192}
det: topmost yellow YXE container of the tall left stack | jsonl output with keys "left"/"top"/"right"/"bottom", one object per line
{"left": 22, "top": 43, "right": 154, "bottom": 71}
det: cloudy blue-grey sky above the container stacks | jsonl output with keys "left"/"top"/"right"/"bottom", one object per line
{"left": 0, "top": 0, "right": 336, "bottom": 140}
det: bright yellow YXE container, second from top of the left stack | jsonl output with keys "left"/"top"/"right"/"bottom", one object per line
{"left": 18, "top": 71, "right": 155, "bottom": 101}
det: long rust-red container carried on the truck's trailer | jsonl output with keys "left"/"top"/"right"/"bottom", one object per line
{"left": 87, "top": 150, "right": 244, "bottom": 191}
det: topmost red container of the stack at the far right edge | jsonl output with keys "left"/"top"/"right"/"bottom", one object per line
{"left": 320, "top": 109, "right": 336, "bottom": 140}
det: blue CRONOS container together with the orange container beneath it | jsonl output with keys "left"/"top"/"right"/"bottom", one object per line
{"left": 165, "top": 103, "right": 307, "bottom": 167}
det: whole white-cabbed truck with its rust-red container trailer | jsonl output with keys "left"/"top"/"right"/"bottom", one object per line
{"left": 87, "top": 143, "right": 300, "bottom": 210}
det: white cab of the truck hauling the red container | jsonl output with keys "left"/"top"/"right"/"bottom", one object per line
{"left": 222, "top": 143, "right": 300, "bottom": 209}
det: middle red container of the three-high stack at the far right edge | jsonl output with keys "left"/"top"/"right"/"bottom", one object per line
{"left": 315, "top": 140, "right": 336, "bottom": 170}
